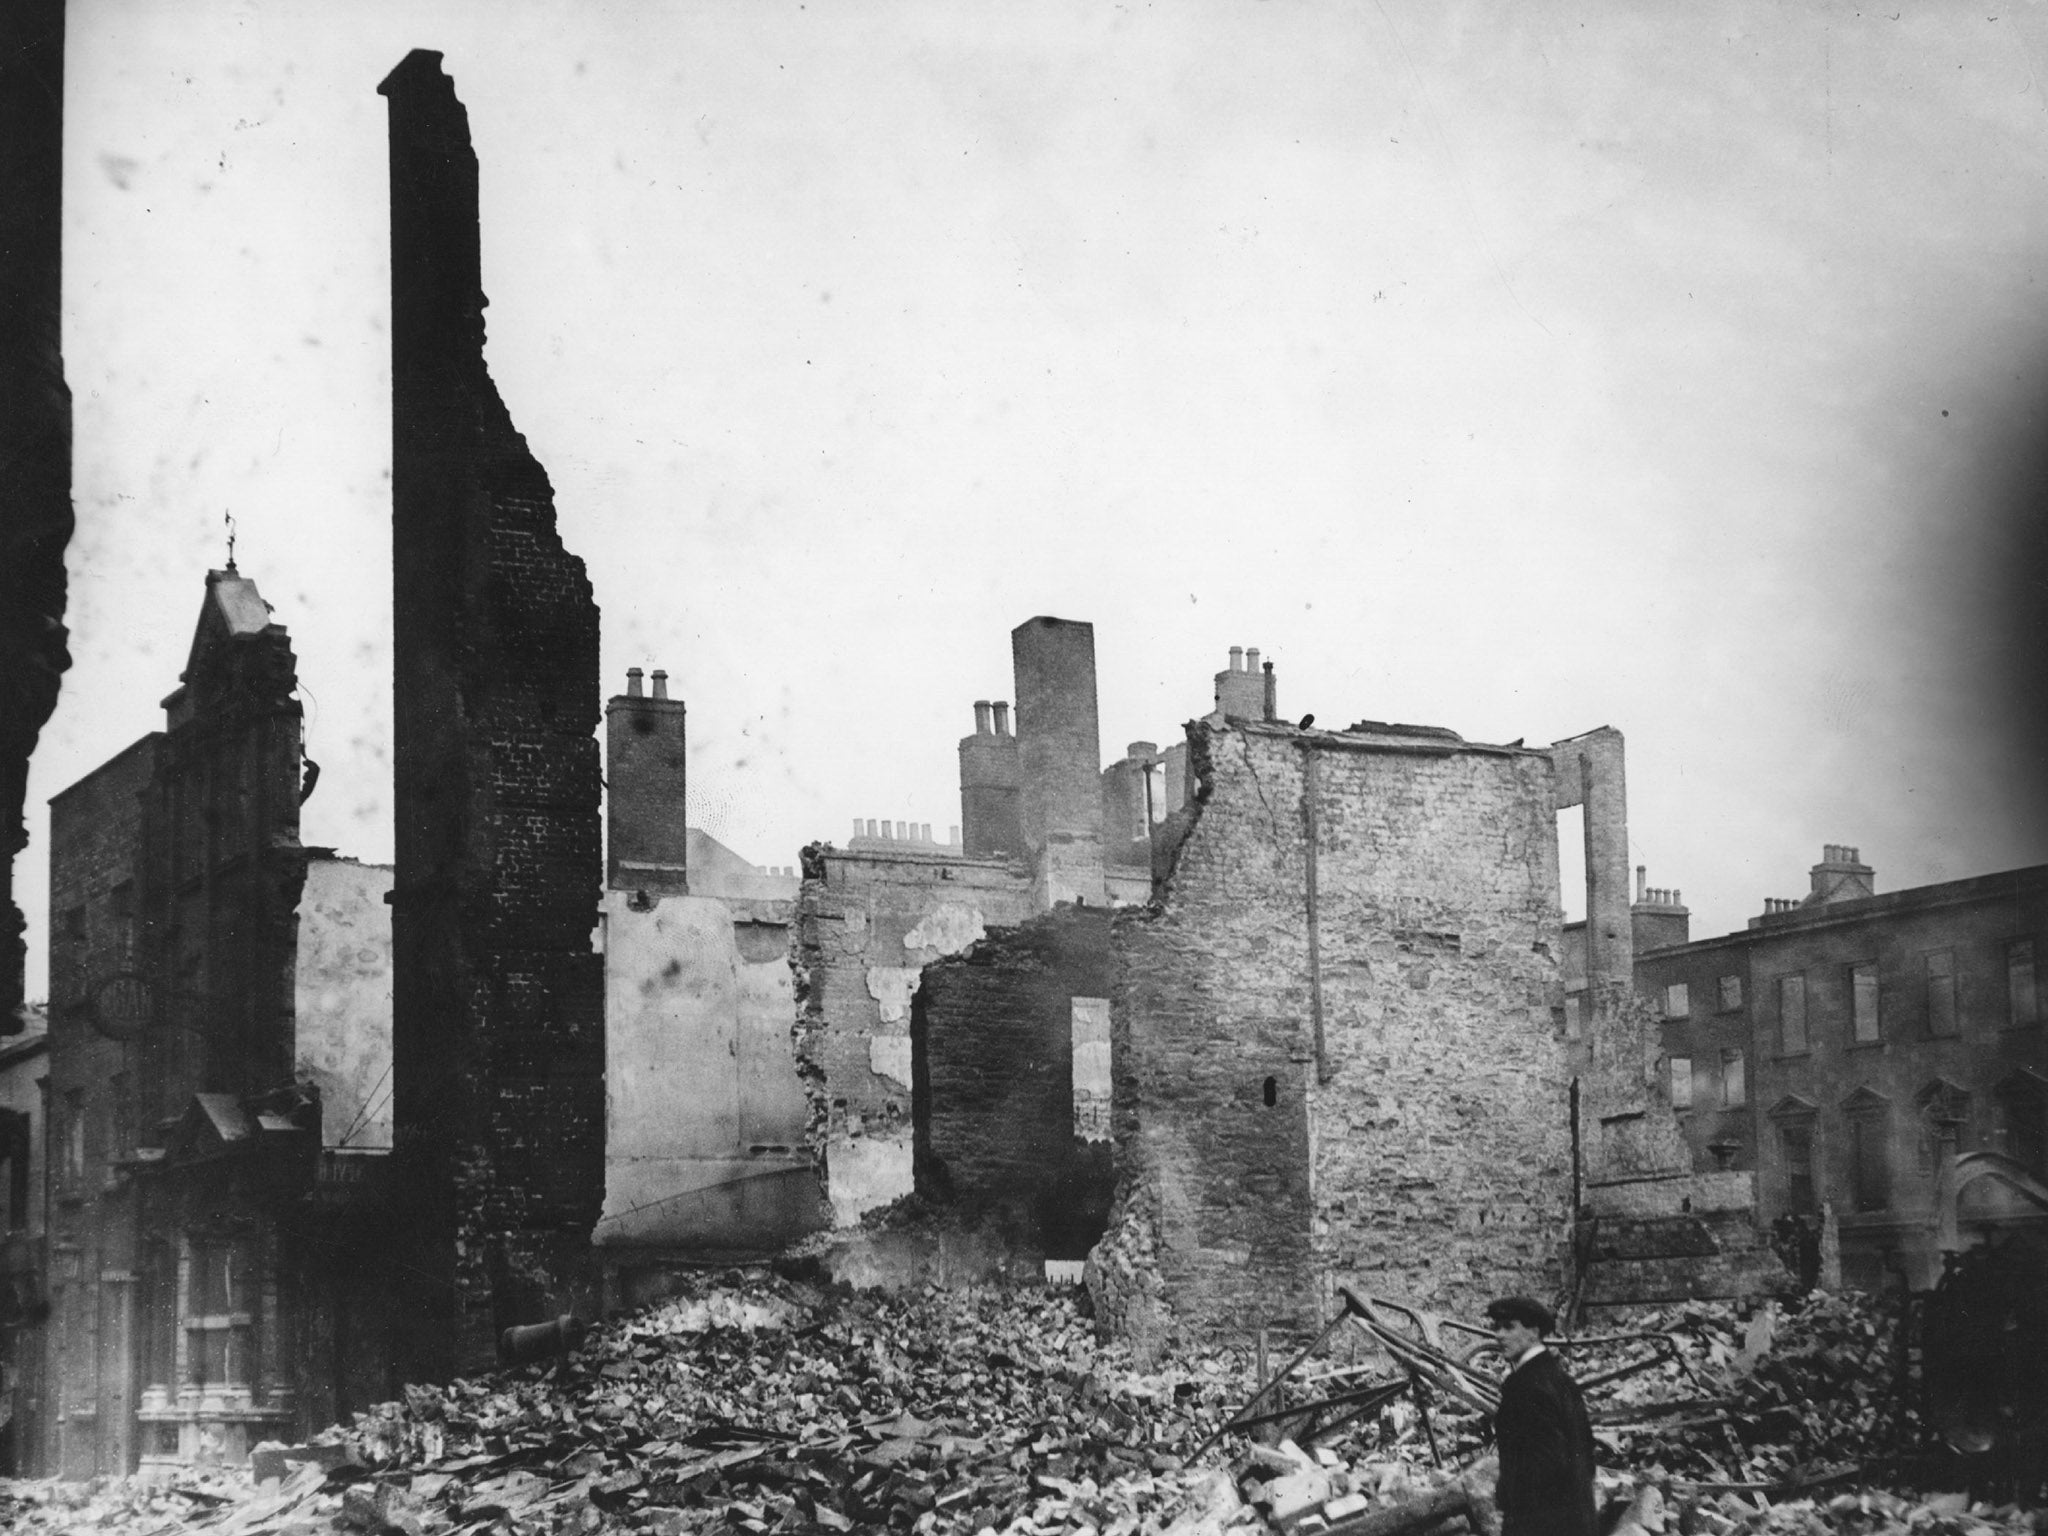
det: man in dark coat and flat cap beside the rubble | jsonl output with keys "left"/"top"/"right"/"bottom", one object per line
{"left": 1487, "top": 1296, "right": 1597, "bottom": 1536}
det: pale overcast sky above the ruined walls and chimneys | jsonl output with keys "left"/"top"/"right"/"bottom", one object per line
{"left": 16, "top": 0, "right": 2048, "bottom": 997}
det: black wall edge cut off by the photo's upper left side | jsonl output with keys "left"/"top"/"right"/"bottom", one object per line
{"left": 0, "top": 0, "right": 72, "bottom": 1036}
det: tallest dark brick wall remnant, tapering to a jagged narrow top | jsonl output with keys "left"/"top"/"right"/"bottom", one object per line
{"left": 377, "top": 51, "right": 604, "bottom": 1376}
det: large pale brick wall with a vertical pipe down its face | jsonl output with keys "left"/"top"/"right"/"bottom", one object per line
{"left": 1092, "top": 723, "right": 1571, "bottom": 1339}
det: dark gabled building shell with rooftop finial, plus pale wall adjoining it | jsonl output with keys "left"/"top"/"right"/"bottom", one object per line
{"left": 39, "top": 567, "right": 391, "bottom": 1477}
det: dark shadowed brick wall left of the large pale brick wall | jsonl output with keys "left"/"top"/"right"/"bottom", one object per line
{"left": 911, "top": 905, "right": 1114, "bottom": 1260}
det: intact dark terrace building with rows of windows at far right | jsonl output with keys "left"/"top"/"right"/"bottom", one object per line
{"left": 1636, "top": 844, "right": 2048, "bottom": 1288}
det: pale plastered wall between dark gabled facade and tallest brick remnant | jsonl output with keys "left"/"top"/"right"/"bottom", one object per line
{"left": 293, "top": 858, "right": 391, "bottom": 1151}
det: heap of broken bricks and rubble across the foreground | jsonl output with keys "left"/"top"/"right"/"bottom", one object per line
{"left": 0, "top": 1270, "right": 2048, "bottom": 1536}
